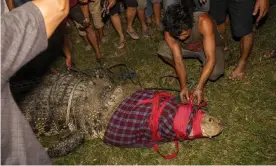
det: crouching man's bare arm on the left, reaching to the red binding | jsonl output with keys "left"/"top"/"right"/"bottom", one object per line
{"left": 165, "top": 32, "right": 189, "bottom": 102}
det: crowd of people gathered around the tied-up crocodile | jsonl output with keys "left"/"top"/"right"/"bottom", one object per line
{"left": 1, "top": 0, "right": 275, "bottom": 164}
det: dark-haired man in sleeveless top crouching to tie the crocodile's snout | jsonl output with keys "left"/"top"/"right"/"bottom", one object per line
{"left": 158, "top": 4, "right": 224, "bottom": 104}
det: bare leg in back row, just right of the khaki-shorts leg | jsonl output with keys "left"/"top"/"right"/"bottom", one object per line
{"left": 110, "top": 2, "right": 125, "bottom": 49}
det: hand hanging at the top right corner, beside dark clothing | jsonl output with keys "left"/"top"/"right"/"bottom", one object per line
{"left": 253, "top": 0, "right": 269, "bottom": 23}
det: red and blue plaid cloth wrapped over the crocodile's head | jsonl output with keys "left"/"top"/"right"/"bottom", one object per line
{"left": 104, "top": 90, "right": 180, "bottom": 147}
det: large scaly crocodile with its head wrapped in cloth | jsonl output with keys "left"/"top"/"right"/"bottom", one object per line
{"left": 16, "top": 70, "right": 222, "bottom": 157}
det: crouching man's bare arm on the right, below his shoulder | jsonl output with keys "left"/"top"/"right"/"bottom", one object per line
{"left": 196, "top": 14, "right": 216, "bottom": 90}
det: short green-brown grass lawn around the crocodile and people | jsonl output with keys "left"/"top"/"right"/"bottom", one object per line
{"left": 50, "top": 8, "right": 276, "bottom": 165}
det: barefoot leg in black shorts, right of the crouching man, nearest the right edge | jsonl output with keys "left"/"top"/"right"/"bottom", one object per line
{"left": 229, "top": 0, "right": 254, "bottom": 79}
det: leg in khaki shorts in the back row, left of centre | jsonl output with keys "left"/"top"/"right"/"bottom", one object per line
{"left": 89, "top": 0, "right": 104, "bottom": 42}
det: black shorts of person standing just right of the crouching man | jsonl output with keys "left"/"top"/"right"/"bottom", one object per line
{"left": 209, "top": 0, "right": 255, "bottom": 37}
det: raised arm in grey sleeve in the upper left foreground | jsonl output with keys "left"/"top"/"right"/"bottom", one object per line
{"left": 1, "top": 0, "right": 69, "bottom": 84}
